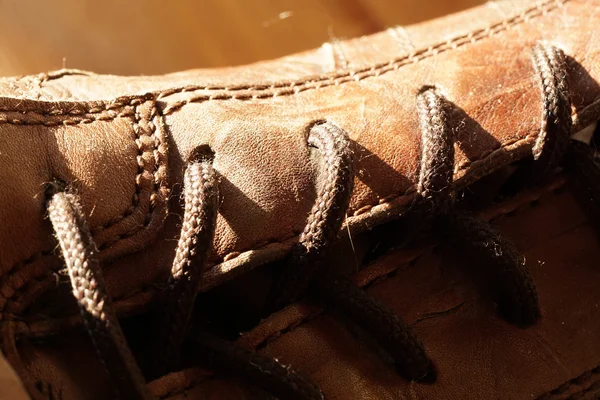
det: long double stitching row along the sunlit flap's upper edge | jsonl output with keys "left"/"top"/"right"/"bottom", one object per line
{"left": 157, "top": 0, "right": 570, "bottom": 115}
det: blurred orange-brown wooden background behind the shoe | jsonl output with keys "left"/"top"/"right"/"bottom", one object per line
{"left": 0, "top": 0, "right": 482, "bottom": 76}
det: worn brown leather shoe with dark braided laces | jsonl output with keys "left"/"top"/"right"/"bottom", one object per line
{"left": 0, "top": 0, "right": 600, "bottom": 400}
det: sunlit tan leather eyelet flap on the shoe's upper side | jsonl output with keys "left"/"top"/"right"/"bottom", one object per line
{"left": 0, "top": 0, "right": 600, "bottom": 398}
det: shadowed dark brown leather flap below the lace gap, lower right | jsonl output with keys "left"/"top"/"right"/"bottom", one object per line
{"left": 151, "top": 176, "right": 600, "bottom": 400}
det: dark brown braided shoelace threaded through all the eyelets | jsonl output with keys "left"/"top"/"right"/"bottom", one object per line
{"left": 47, "top": 44, "right": 600, "bottom": 400}
